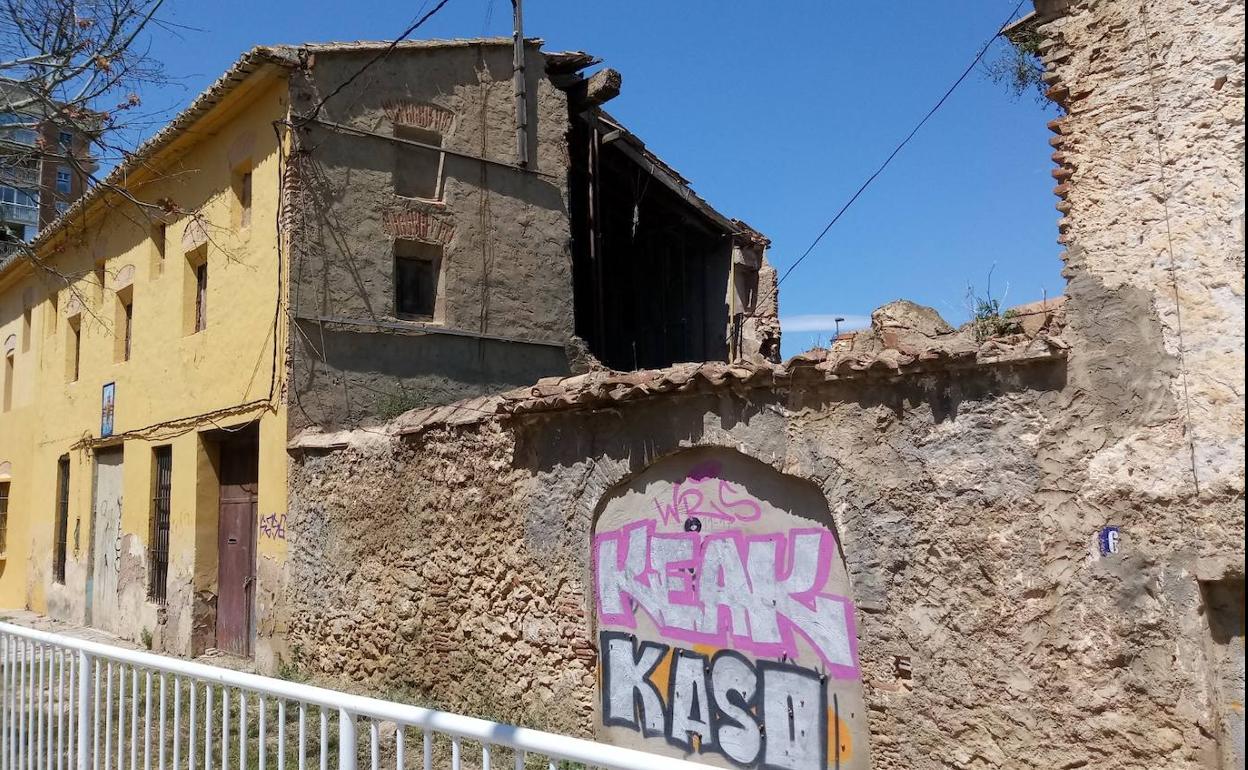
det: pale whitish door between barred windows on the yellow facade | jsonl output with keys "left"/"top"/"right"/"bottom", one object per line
{"left": 86, "top": 447, "right": 122, "bottom": 634}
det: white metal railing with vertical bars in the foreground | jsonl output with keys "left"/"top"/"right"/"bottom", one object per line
{"left": 0, "top": 623, "right": 706, "bottom": 770}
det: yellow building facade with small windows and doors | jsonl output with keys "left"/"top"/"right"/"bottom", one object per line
{"left": 0, "top": 56, "right": 288, "bottom": 663}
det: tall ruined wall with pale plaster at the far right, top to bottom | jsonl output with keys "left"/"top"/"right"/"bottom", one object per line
{"left": 1038, "top": 0, "right": 1244, "bottom": 768}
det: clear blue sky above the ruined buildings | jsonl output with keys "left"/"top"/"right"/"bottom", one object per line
{"left": 136, "top": 0, "right": 1065, "bottom": 356}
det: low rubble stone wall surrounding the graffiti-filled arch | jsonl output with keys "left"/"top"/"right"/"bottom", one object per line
{"left": 288, "top": 362, "right": 1103, "bottom": 769}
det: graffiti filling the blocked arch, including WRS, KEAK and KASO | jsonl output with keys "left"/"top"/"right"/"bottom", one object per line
{"left": 592, "top": 449, "right": 866, "bottom": 770}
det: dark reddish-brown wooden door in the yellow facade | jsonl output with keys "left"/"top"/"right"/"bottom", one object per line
{"left": 217, "top": 437, "right": 260, "bottom": 655}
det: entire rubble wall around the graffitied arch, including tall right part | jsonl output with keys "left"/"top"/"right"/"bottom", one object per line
{"left": 285, "top": 0, "right": 1244, "bottom": 770}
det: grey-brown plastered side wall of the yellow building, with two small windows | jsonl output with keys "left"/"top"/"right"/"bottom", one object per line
{"left": 286, "top": 40, "right": 573, "bottom": 432}
